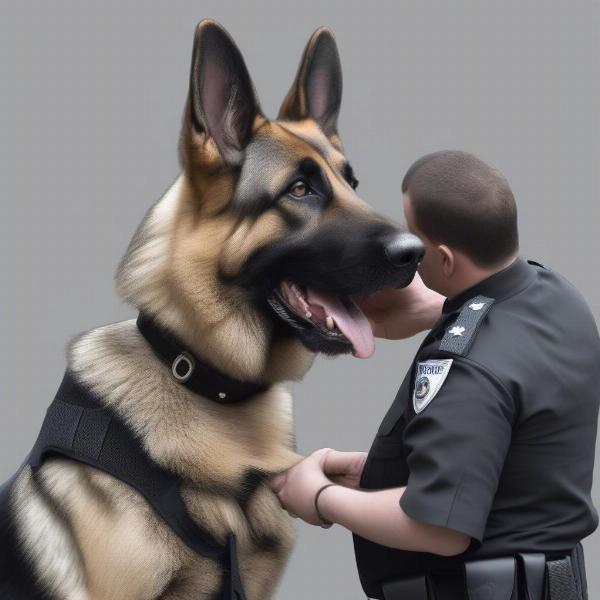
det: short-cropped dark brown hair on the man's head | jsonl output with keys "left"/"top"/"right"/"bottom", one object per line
{"left": 402, "top": 150, "right": 519, "bottom": 267}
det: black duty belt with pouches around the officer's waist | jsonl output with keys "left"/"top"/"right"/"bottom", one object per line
{"left": 382, "top": 544, "right": 588, "bottom": 600}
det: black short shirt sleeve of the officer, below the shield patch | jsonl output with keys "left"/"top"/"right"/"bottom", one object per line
{"left": 400, "top": 357, "right": 515, "bottom": 545}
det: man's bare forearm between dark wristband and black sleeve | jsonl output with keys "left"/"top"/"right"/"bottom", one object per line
{"left": 319, "top": 485, "right": 470, "bottom": 556}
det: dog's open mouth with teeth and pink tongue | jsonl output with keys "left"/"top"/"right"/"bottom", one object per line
{"left": 269, "top": 280, "right": 375, "bottom": 358}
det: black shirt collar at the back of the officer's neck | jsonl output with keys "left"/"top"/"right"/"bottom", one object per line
{"left": 442, "top": 256, "right": 536, "bottom": 314}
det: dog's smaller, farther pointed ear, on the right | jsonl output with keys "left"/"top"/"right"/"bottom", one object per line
{"left": 278, "top": 27, "right": 342, "bottom": 135}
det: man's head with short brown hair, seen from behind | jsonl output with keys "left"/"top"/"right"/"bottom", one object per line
{"left": 402, "top": 150, "right": 519, "bottom": 297}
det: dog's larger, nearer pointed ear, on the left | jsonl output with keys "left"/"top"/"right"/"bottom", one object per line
{"left": 189, "top": 19, "right": 261, "bottom": 164}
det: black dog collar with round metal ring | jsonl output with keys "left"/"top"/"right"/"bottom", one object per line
{"left": 136, "top": 312, "right": 269, "bottom": 404}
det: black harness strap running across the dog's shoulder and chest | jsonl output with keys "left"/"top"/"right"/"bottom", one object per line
{"left": 27, "top": 370, "right": 245, "bottom": 600}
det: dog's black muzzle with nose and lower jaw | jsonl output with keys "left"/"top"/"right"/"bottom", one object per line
{"left": 234, "top": 217, "right": 425, "bottom": 357}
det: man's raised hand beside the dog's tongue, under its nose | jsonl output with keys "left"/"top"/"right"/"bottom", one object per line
{"left": 352, "top": 273, "right": 445, "bottom": 340}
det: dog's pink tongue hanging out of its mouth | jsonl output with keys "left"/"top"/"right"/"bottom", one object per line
{"left": 306, "top": 288, "right": 375, "bottom": 358}
